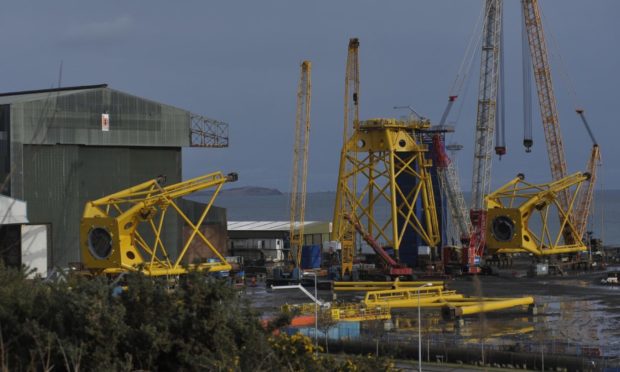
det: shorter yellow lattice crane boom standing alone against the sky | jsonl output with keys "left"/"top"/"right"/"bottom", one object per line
{"left": 289, "top": 61, "right": 312, "bottom": 267}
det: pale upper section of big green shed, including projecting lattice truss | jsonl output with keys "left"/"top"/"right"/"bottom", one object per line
{"left": 0, "top": 84, "right": 228, "bottom": 148}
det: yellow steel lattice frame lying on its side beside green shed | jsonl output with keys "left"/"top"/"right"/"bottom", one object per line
{"left": 80, "top": 172, "right": 237, "bottom": 276}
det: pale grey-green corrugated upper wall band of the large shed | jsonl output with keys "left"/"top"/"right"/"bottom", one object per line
{"left": 11, "top": 88, "right": 190, "bottom": 147}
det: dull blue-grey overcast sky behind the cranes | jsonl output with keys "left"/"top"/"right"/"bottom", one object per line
{"left": 0, "top": 0, "right": 620, "bottom": 191}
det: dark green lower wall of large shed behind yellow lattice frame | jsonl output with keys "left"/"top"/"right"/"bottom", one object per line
{"left": 23, "top": 145, "right": 181, "bottom": 266}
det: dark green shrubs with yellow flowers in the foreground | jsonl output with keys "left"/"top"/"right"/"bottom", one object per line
{"left": 0, "top": 265, "right": 398, "bottom": 371}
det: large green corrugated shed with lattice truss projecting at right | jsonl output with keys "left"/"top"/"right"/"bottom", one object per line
{"left": 0, "top": 84, "right": 228, "bottom": 267}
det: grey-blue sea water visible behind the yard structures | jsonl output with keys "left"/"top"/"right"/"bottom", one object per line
{"left": 197, "top": 190, "right": 620, "bottom": 245}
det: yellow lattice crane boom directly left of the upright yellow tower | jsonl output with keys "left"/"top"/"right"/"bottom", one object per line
{"left": 332, "top": 38, "right": 360, "bottom": 273}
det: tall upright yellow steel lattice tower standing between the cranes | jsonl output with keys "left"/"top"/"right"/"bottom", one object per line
{"left": 332, "top": 119, "right": 439, "bottom": 276}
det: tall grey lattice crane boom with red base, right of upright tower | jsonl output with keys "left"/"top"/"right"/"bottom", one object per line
{"left": 463, "top": 0, "right": 502, "bottom": 273}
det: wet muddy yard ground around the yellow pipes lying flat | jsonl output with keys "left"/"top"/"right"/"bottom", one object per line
{"left": 246, "top": 268, "right": 620, "bottom": 357}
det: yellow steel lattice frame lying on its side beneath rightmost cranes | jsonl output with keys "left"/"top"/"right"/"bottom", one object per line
{"left": 486, "top": 172, "right": 589, "bottom": 256}
